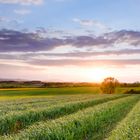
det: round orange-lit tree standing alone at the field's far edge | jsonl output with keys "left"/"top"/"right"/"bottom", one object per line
{"left": 101, "top": 77, "right": 119, "bottom": 94}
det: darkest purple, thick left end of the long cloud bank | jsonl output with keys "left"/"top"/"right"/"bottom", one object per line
{"left": 0, "top": 29, "right": 63, "bottom": 52}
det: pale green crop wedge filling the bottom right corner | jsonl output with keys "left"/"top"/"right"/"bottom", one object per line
{"left": 107, "top": 101, "right": 140, "bottom": 140}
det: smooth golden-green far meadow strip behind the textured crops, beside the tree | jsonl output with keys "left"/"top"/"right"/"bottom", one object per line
{"left": 0, "top": 87, "right": 140, "bottom": 97}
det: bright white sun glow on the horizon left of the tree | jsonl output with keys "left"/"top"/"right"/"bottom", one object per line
{"left": 44, "top": 67, "right": 112, "bottom": 82}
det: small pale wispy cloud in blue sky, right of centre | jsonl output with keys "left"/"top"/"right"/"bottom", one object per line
{"left": 73, "top": 18, "right": 109, "bottom": 30}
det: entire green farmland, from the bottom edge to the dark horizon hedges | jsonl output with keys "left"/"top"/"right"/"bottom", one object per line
{"left": 0, "top": 87, "right": 140, "bottom": 140}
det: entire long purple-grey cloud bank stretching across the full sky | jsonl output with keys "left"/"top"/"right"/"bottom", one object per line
{"left": 0, "top": 29, "right": 140, "bottom": 52}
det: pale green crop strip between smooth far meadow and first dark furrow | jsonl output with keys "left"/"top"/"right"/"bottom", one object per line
{"left": 0, "top": 94, "right": 104, "bottom": 113}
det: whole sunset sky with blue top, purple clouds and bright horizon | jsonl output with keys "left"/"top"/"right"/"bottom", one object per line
{"left": 0, "top": 0, "right": 140, "bottom": 82}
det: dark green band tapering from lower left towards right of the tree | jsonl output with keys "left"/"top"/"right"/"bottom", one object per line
{"left": 0, "top": 95, "right": 128, "bottom": 135}
